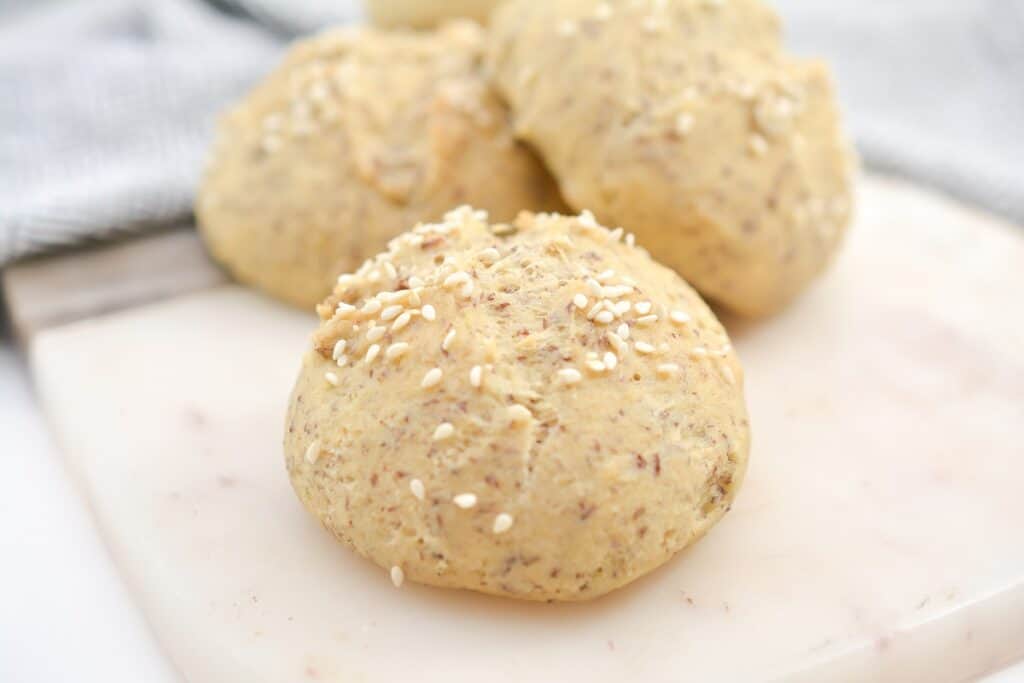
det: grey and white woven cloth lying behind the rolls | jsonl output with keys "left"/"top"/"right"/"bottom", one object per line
{"left": 0, "top": 0, "right": 1024, "bottom": 264}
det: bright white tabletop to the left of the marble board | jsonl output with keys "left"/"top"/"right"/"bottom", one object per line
{"left": 0, "top": 348, "right": 179, "bottom": 683}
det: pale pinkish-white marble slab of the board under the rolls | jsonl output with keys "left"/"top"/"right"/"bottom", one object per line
{"left": 32, "top": 180, "right": 1024, "bottom": 683}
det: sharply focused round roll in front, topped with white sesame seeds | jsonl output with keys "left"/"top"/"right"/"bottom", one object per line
{"left": 285, "top": 208, "right": 750, "bottom": 600}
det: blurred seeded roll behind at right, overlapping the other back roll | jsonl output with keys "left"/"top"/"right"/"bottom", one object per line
{"left": 488, "top": 0, "right": 856, "bottom": 315}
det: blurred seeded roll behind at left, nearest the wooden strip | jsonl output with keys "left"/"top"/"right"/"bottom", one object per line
{"left": 197, "top": 22, "right": 562, "bottom": 308}
